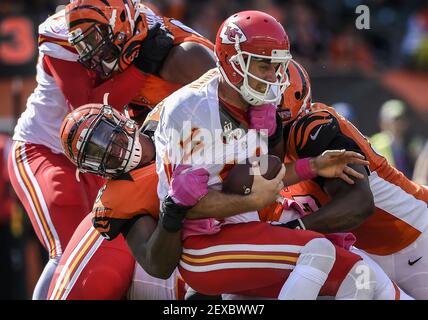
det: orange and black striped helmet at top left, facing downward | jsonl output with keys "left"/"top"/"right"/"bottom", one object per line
{"left": 66, "top": 0, "right": 139, "bottom": 78}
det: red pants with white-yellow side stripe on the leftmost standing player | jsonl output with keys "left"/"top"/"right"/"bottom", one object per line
{"left": 8, "top": 142, "right": 104, "bottom": 258}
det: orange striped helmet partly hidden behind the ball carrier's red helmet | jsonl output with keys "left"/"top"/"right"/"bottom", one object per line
{"left": 278, "top": 60, "right": 312, "bottom": 125}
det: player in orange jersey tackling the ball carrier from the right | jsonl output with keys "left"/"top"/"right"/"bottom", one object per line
{"left": 270, "top": 61, "right": 428, "bottom": 299}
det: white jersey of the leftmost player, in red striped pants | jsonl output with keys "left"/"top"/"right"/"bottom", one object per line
{"left": 13, "top": 10, "right": 78, "bottom": 153}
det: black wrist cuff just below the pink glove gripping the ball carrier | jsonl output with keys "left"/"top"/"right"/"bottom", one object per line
{"left": 159, "top": 196, "right": 192, "bottom": 232}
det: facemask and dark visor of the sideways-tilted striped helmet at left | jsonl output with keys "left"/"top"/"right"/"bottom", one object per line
{"left": 76, "top": 105, "right": 142, "bottom": 178}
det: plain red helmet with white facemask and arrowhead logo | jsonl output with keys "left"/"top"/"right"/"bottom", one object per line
{"left": 215, "top": 11, "right": 291, "bottom": 105}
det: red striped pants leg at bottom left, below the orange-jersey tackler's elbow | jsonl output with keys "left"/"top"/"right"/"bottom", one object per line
{"left": 48, "top": 214, "right": 135, "bottom": 300}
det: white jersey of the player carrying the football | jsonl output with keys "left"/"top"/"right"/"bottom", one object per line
{"left": 153, "top": 69, "right": 268, "bottom": 223}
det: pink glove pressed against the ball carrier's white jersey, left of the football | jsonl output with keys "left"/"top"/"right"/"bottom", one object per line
{"left": 168, "top": 165, "right": 209, "bottom": 207}
